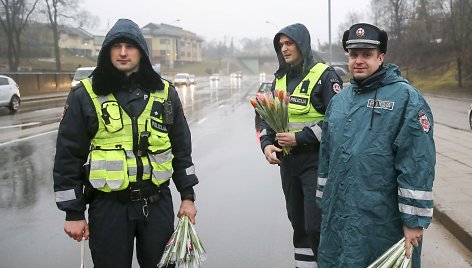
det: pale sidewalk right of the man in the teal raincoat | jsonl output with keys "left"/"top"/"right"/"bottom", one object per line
{"left": 432, "top": 124, "right": 472, "bottom": 251}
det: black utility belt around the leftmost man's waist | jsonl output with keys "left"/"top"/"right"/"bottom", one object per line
{"left": 85, "top": 180, "right": 169, "bottom": 204}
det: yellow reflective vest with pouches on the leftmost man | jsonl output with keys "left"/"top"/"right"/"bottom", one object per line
{"left": 82, "top": 79, "right": 174, "bottom": 192}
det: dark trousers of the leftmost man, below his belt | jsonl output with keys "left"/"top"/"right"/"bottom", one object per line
{"left": 88, "top": 186, "right": 174, "bottom": 268}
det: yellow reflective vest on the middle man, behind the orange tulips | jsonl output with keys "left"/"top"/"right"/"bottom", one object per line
{"left": 275, "top": 63, "right": 329, "bottom": 132}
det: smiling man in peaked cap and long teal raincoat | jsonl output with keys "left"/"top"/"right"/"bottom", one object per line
{"left": 317, "top": 23, "right": 436, "bottom": 268}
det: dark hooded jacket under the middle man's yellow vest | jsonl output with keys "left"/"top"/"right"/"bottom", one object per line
{"left": 261, "top": 23, "right": 342, "bottom": 151}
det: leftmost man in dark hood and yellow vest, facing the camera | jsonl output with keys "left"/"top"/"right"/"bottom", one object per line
{"left": 54, "top": 19, "right": 198, "bottom": 268}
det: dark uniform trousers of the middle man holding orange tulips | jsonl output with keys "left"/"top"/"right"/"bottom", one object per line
{"left": 280, "top": 147, "right": 321, "bottom": 262}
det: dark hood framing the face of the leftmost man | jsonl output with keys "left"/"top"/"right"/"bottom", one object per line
{"left": 92, "top": 19, "right": 164, "bottom": 95}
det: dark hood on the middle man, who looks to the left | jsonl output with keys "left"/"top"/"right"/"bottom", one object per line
{"left": 274, "top": 23, "right": 315, "bottom": 77}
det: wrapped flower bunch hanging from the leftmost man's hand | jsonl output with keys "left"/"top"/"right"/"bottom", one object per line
{"left": 157, "top": 215, "right": 206, "bottom": 268}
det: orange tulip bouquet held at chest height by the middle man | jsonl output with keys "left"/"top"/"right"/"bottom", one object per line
{"left": 249, "top": 89, "right": 290, "bottom": 154}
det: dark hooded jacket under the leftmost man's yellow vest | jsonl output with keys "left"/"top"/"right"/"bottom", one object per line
{"left": 53, "top": 19, "right": 198, "bottom": 220}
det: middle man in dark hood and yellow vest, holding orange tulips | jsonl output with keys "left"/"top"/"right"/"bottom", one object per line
{"left": 260, "top": 23, "right": 342, "bottom": 267}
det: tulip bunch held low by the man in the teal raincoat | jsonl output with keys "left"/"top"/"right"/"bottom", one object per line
{"left": 367, "top": 238, "right": 413, "bottom": 268}
